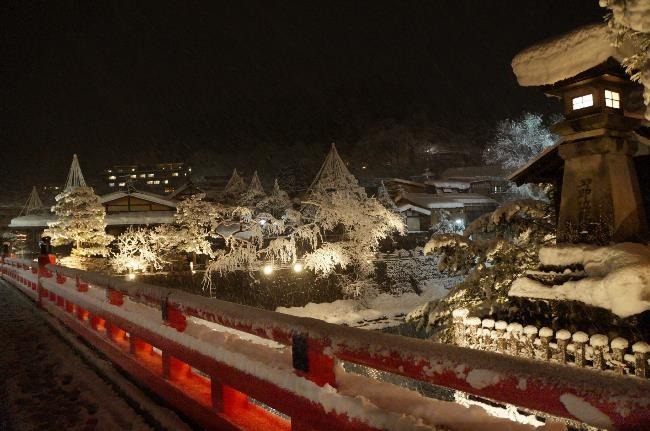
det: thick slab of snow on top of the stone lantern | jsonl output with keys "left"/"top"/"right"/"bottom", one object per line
{"left": 512, "top": 23, "right": 633, "bottom": 87}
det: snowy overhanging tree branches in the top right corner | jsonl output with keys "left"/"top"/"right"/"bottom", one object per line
{"left": 600, "top": 0, "right": 650, "bottom": 120}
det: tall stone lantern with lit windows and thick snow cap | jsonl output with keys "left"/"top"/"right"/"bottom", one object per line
{"left": 513, "top": 26, "right": 650, "bottom": 243}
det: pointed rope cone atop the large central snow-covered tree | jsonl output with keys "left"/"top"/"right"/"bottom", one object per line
{"left": 308, "top": 143, "right": 366, "bottom": 197}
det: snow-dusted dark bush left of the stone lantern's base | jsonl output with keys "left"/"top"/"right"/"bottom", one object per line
{"left": 425, "top": 200, "right": 555, "bottom": 341}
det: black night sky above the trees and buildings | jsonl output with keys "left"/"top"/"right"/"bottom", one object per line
{"left": 0, "top": 0, "right": 603, "bottom": 196}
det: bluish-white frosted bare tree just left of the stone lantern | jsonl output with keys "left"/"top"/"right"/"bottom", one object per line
{"left": 483, "top": 113, "right": 555, "bottom": 170}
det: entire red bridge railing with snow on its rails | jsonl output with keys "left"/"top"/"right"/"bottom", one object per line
{"left": 0, "top": 257, "right": 650, "bottom": 430}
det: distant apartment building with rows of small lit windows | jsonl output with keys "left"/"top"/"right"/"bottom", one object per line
{"left": 103, "top": 162, "right": 192, "bottom": 195}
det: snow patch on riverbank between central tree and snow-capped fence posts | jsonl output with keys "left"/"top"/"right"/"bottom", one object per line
{"left": 276, "top": 277, "right": 462, "bottom": 329}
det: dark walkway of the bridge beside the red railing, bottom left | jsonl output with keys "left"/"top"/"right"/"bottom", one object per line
{"left": 0, "top": 281, "right": 187, "bottom": 431}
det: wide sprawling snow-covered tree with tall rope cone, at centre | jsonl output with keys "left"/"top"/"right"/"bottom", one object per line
{"left": 205, "top": 146, "right": 405, "bottom": 298}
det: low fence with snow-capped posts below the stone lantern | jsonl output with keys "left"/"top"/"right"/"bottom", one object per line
{"left": 453, "top": 308, "right": 650, "bottom": 378}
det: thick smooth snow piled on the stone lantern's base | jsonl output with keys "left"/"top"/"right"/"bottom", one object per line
{"left": 508, "top": 243, "right": 650, "bottom": 318}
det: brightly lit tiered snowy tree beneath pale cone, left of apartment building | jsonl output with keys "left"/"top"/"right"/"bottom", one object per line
{"left": 44, "top": 187, "right": 113, "bottom": 256}
